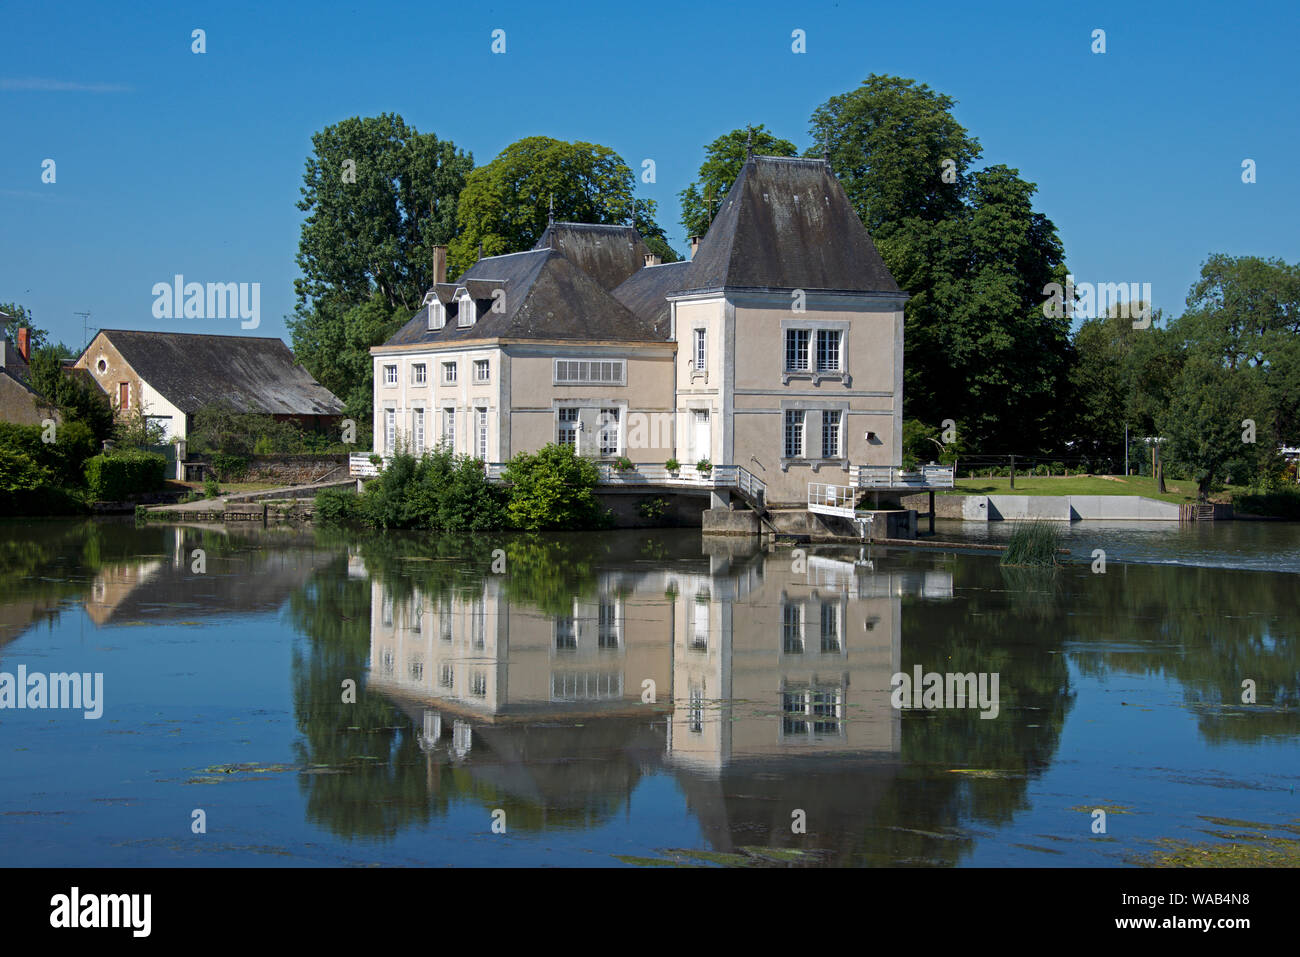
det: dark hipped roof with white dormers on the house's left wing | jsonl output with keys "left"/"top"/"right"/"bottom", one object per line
{"left": 384, "top": 247, "right": 664, "bottom": 346}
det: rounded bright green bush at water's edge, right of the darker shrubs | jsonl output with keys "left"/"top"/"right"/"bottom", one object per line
{"left": 503, "top": 443, "right": 603, "bottom": 529}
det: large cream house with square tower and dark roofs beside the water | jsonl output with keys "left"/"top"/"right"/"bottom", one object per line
{"left": 371, "top": 156, "right": 907, "bottom": 503}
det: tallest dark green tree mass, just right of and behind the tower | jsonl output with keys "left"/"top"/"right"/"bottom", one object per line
{"left": 807, "top": 74, "right": 1071, "bottom": 452}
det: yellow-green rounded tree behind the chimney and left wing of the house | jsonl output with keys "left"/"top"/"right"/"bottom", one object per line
{"left": 450, "top": 137, "right": 676, "bottom": 276}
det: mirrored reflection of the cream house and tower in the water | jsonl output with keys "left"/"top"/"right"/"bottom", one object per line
{"left": 354, "top": 542, "right": 953, "bottom": 853}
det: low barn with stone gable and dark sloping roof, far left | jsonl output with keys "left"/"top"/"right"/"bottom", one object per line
{"left": 74, "top": 329, "right": 343, "bottom": 441}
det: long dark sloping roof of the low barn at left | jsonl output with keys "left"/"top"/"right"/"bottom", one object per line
{"left": 90, "top": 329, "right": 343, "bottom": 415}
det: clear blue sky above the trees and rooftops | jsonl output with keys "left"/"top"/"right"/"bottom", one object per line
{"left": 0, "top": 0, "right": 1300, "bottom": 347}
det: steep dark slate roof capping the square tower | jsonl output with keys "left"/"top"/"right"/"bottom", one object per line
{"left": 684, "top": 156, "right": 900, "bottom": 293}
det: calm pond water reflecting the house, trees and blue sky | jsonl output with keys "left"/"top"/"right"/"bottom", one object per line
{"left": 0, "top": 523, "right": 1300, "bottom": 866}
